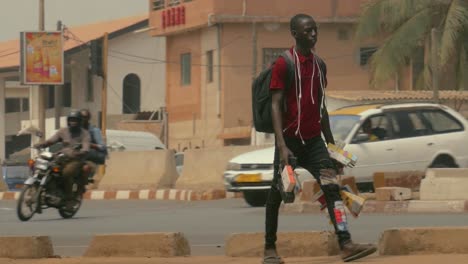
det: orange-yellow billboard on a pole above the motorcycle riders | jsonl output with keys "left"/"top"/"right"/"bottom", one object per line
{"left": 20, "top": 31, "right": 64, "bottom": 85}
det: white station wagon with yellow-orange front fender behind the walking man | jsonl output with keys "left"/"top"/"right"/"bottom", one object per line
{"left": 224, "top": 103, "right": 468, "bottom": 206}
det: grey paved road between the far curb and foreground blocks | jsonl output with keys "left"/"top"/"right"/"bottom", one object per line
{"left": 0, "top": 199, "right": 468, "bottom": 256}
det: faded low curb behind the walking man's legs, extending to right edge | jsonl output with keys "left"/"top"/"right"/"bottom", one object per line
{"left": 281, "top": 200, "right": 468, "bottom": 214}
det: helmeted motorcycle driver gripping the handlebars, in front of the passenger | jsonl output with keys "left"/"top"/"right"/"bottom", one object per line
{"left": 34, "top": 110, "right": 91, "bottom": 208}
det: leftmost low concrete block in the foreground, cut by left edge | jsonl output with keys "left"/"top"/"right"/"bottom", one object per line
{"left": 0, "top": 236, "right": 54, "bottom": 259}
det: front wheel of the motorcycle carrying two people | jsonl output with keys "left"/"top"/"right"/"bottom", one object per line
{"left": 16, "top": 185, "right": 40, "bottom": 221}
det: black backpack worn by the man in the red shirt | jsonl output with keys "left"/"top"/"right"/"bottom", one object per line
{"left": 252, "top": 50, "right": 327, "bottom": 133}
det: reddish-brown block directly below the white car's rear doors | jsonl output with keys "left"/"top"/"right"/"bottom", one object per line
{"left": 374, "top": 171, "right": 424, "bottom": 191}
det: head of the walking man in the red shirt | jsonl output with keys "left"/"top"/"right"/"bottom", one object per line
{"left": 289, "top": 14, "right": 318, "bottom": 49}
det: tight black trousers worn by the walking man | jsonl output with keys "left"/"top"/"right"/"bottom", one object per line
{"left": 265, "top": 136, "right": 351, "bottom": 249}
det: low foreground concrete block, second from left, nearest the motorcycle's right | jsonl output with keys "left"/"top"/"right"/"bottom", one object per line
{"left": 84, "top": 233, "right": 190, "bottom": 257}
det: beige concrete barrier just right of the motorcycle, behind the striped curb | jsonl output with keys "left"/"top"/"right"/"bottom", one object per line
{"left": 99, "top": 150, "right": 178, "bottom": 190}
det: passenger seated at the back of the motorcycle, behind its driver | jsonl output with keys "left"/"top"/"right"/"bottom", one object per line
{"left": 80, "top": 108, "right": 108, "bottom": 178}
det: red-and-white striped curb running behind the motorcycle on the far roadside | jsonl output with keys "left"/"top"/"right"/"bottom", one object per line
{"left": 0, "top": 189, "right": 239, "bottom": 201}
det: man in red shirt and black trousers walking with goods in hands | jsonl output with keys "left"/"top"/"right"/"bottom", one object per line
{"left": 263, "top": 14, "right": 376, "bottom": 264}
